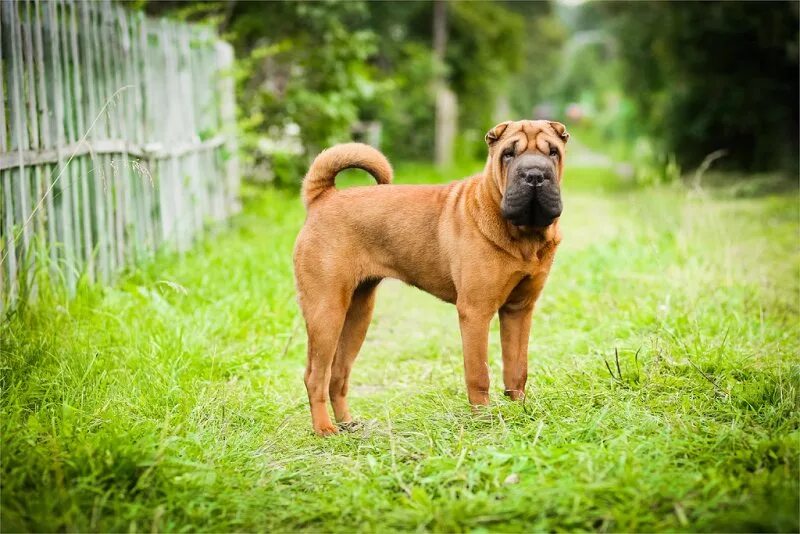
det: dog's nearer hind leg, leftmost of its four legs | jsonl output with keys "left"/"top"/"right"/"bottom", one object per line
{"left": 303, "top": 292, "right": 350, "bottom": 436}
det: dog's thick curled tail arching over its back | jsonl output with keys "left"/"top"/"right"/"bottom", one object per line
{"left": 302, "top": 143, "right": 392, "bottom": 209}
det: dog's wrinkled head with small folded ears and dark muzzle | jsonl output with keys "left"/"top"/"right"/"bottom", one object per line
{"left": 486, "top": 120, "right": 569, "bottom": 228}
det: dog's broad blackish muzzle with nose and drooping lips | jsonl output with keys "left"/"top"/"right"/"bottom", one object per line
{"left": 500, "top": 155, "right": 563, "bottom": 227}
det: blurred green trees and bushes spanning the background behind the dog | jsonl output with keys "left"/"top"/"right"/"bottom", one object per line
{"left": 140, "top": 0, "right": 800, "bottom": 183}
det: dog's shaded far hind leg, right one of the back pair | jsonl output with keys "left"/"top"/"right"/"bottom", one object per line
{"left": 329, "top": 280, "right": 379, "bottom": 423}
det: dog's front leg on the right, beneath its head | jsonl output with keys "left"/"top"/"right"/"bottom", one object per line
{"left": 500, "top": 304, "right": 533, "bottom": 400}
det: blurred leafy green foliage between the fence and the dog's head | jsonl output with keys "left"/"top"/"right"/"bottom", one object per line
{"left": 145, "top": 0, "right": 540, "bottom": 180}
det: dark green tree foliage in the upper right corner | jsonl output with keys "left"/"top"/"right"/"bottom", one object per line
{"left": 597, "top": 2, "right": 800, "bottom": 177}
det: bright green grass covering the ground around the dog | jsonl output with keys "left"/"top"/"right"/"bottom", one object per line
{"left": 0, "top": 160, "right": 800, "bottom": 531}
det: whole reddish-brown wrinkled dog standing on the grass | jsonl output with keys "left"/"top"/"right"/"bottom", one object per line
{"left": 294, "top": 121, "right": 569, "bottom": 435}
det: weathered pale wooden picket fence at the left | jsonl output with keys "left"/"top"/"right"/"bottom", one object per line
{"left": 0, "top": 0, "right": 239, "bottom": 309}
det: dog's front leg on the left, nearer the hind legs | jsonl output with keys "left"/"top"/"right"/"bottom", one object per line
{"left": 457, "top": 305, "right": 494, "bottom": 405}
